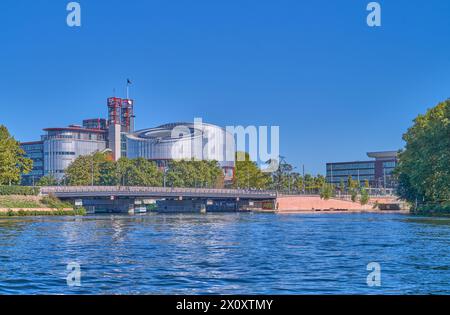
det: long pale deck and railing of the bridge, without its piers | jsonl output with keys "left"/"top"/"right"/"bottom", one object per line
{"left": 41, "top": 186, "right": 277, "bottom": 200}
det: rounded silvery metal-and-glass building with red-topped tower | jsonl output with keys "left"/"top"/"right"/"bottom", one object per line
{"left": 21, "top": 97, "right": 235, "bottom": 185}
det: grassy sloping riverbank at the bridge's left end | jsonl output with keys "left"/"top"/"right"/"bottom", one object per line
{"left": 0, "top": 195, "right": 86, "bottom": 217}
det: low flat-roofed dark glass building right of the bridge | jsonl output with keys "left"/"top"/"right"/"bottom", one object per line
{"left": 327, "top": 151, "right": 398, "bottom": 188}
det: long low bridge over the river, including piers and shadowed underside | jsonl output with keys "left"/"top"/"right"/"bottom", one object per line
{"left": 41, "top": 186, "right": 277, "bottom": 212}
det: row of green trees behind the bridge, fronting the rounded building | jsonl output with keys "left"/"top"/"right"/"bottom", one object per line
{"left": 37, "top": 152, "right": 342, "bottom": 197}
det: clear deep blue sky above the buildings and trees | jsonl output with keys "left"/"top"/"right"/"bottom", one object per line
{"left": 0, "top": 0, "right": 450, "bottom": 173}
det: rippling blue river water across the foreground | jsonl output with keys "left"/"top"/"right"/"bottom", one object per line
{"left": 0, "top": 213, "right": 450, "bottom": 294}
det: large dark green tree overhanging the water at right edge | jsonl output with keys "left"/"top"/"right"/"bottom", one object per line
{"left": 395, "top": 99, "right": 450, "bottom": 212}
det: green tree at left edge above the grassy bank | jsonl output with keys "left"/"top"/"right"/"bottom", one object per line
{"left": 0, "top": 125, "right": 33, "bottom": 185}
